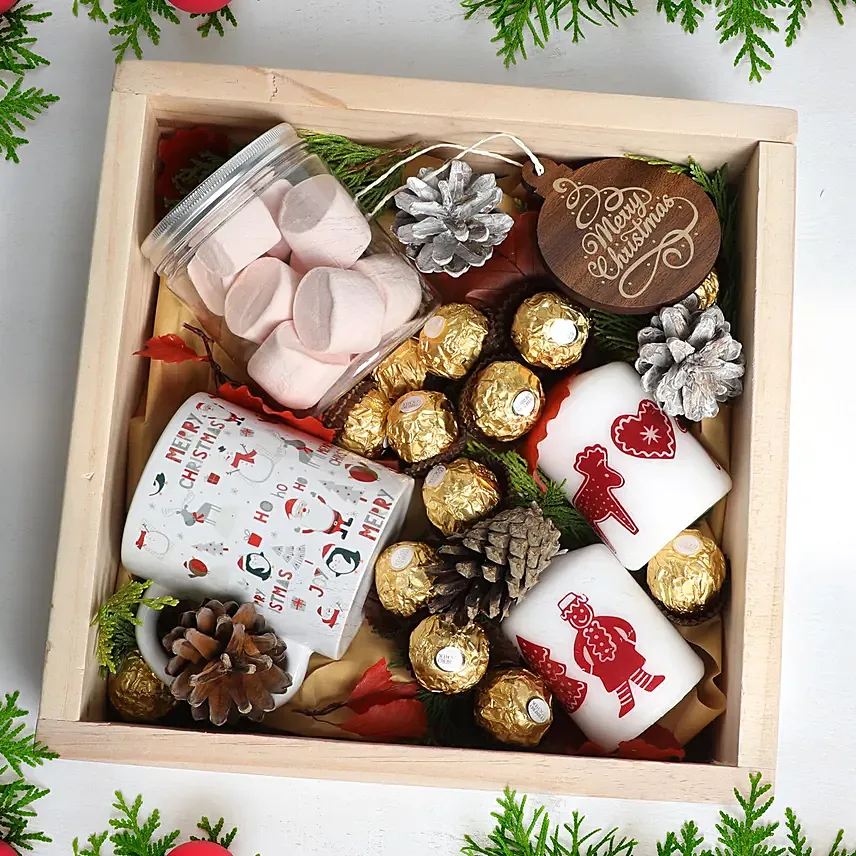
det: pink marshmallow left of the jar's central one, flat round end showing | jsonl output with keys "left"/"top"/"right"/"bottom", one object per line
{"left": 223, "top": 258, "right": 300, "bottom": 344}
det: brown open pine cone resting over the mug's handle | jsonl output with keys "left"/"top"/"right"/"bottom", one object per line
{"left": 163, "top": 600, "right": 292, "bottom": 725}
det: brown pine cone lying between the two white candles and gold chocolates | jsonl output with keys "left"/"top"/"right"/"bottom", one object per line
{"left": 428, "top": 504, "right": 560, "bottom": 625}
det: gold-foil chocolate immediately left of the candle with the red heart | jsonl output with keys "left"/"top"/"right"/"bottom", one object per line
{"left": 461, "top": 361, "right": 544, "bottom": 443}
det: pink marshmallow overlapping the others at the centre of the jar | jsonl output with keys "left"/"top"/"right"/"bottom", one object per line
{"left": 294, "top": 267, "right": 386, "bottom": 354}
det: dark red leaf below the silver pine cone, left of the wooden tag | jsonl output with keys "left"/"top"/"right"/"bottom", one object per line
{"left": 430, "top": 211, "right": 546, "bottom": 309}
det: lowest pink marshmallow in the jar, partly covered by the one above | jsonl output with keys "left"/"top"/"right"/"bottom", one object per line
{"left": 247, "top": 321, "right": 350, "bottom": 410}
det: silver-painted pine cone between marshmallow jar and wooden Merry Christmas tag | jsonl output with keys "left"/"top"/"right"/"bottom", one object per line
{"left": 392, "top": 160, "right": 514, "bottom": 276}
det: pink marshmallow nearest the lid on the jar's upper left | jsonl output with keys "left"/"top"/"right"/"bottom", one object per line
{"left": 196, "top": 196, "right": 282, "bottom": 276}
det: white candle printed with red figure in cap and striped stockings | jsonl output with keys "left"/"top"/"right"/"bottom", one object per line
{"left": 502, "top": 544, "right": 704, "bottom": 752}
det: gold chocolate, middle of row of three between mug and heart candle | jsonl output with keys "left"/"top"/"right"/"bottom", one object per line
{"left": 386, "top": 389, "right": 458, "bottom": 464}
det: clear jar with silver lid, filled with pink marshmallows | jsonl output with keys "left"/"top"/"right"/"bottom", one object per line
{"left": 142, "top": 124, "right": 438, "bottom": 413}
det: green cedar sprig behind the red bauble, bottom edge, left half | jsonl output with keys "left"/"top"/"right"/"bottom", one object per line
{"left": 71, "top": 791, "right": 256, "bottom": 856}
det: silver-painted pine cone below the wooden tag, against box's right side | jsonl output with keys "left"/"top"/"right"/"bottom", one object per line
{"left": 636, "top": 301, "right": 745, "bottom": 422}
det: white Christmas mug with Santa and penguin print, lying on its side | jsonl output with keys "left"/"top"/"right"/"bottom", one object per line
{"left": 122, "top": 393, "right": 413, "bottom": 704}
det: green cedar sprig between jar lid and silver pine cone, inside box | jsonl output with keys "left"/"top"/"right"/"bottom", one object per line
{"left": 298, "top": 129, "right": 419, "bottom": 217}
